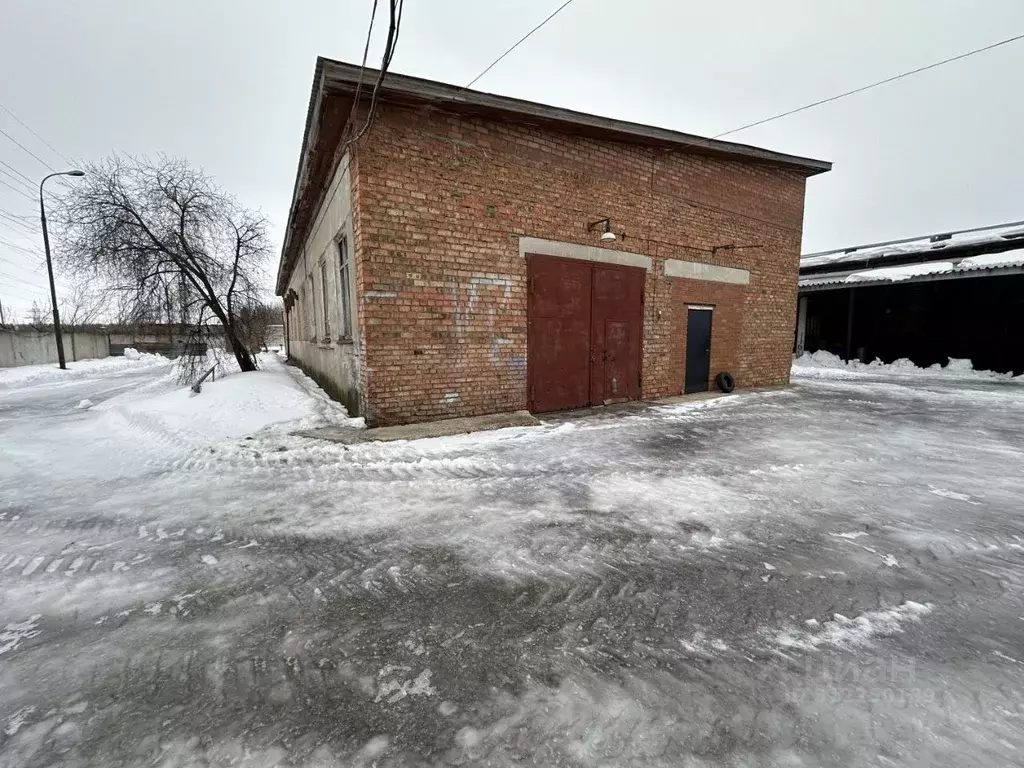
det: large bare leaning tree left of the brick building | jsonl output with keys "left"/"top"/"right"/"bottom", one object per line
{"left": 56, "top": 156, "right": 270, "bottom": 371}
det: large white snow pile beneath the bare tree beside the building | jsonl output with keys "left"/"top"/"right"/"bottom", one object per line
{"left": 91, "top": 354, "right": 362, "bottom": 444}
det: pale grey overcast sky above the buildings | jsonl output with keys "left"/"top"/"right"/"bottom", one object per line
{"left": 0, "top": 0, "right": 1024, "bottom": 312}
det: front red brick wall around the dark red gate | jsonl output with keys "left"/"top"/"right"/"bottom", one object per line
{"left": 352, "top": 106, "right": 804, "bottom": 424}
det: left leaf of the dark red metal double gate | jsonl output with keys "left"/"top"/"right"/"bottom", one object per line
{"left": 526, "top": 255, "right": 593, "bottom": 413}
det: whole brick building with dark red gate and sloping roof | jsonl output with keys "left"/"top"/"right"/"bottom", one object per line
{"left": 276, "top": 58, "right": 830, "bottom": 424}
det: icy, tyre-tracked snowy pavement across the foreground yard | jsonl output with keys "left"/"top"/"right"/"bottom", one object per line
{"left": 0, "top": 367, "right": 1024, "bottom": 768}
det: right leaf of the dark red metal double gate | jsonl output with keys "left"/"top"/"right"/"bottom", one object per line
{"left": 590, "top": 264, "right": 644, "bottom": 406}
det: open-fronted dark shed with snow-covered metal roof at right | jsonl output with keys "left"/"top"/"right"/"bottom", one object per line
{"left": 797, "top": 221, "right": 1024, "bottom": 374}
